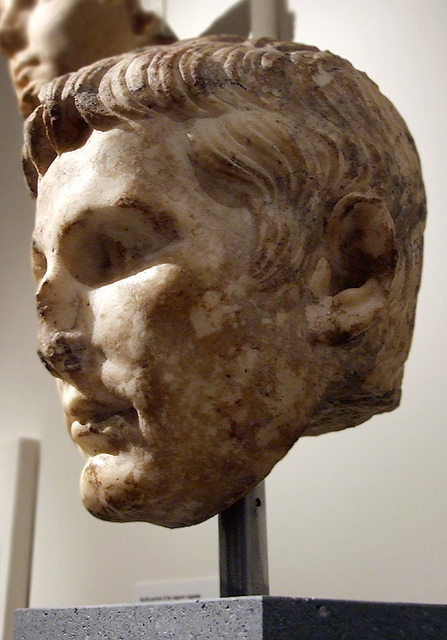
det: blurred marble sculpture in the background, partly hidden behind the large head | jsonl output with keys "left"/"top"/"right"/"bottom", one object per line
{"left": 0, "top": 0, "right": 175, "bottom": 116}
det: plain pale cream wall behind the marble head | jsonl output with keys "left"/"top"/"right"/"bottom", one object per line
{"left": 0, "top": 0, "right": 447, "bottom": 607}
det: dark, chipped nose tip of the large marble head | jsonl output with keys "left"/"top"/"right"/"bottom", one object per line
{"left": 37, "top": 328, "right": 85, "bottom": 379}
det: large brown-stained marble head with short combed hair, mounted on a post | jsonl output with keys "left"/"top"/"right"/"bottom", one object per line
{"left": 25, "top": 37, "right": 425, "bottom": 527}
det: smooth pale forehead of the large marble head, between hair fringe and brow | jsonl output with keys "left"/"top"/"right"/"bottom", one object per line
{"left": 35, "top": 119, "right": 224, "bottom": 234}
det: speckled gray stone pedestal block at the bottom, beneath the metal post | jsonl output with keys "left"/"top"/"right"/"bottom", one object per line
{"left": 14, "top": 596, "right": 447, "bottom": 640}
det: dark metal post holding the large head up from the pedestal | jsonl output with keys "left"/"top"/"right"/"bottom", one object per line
{"left": 219, "top": 482, "right": 269, "bottom": 598}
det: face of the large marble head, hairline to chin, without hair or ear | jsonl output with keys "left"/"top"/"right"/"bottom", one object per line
{"left": 34, "top": 119, "right": 318, "bottom": 526}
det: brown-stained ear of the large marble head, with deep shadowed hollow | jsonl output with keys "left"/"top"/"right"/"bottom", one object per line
{"left": 306, "top": 193, "right": 397, "bottom": 344}
